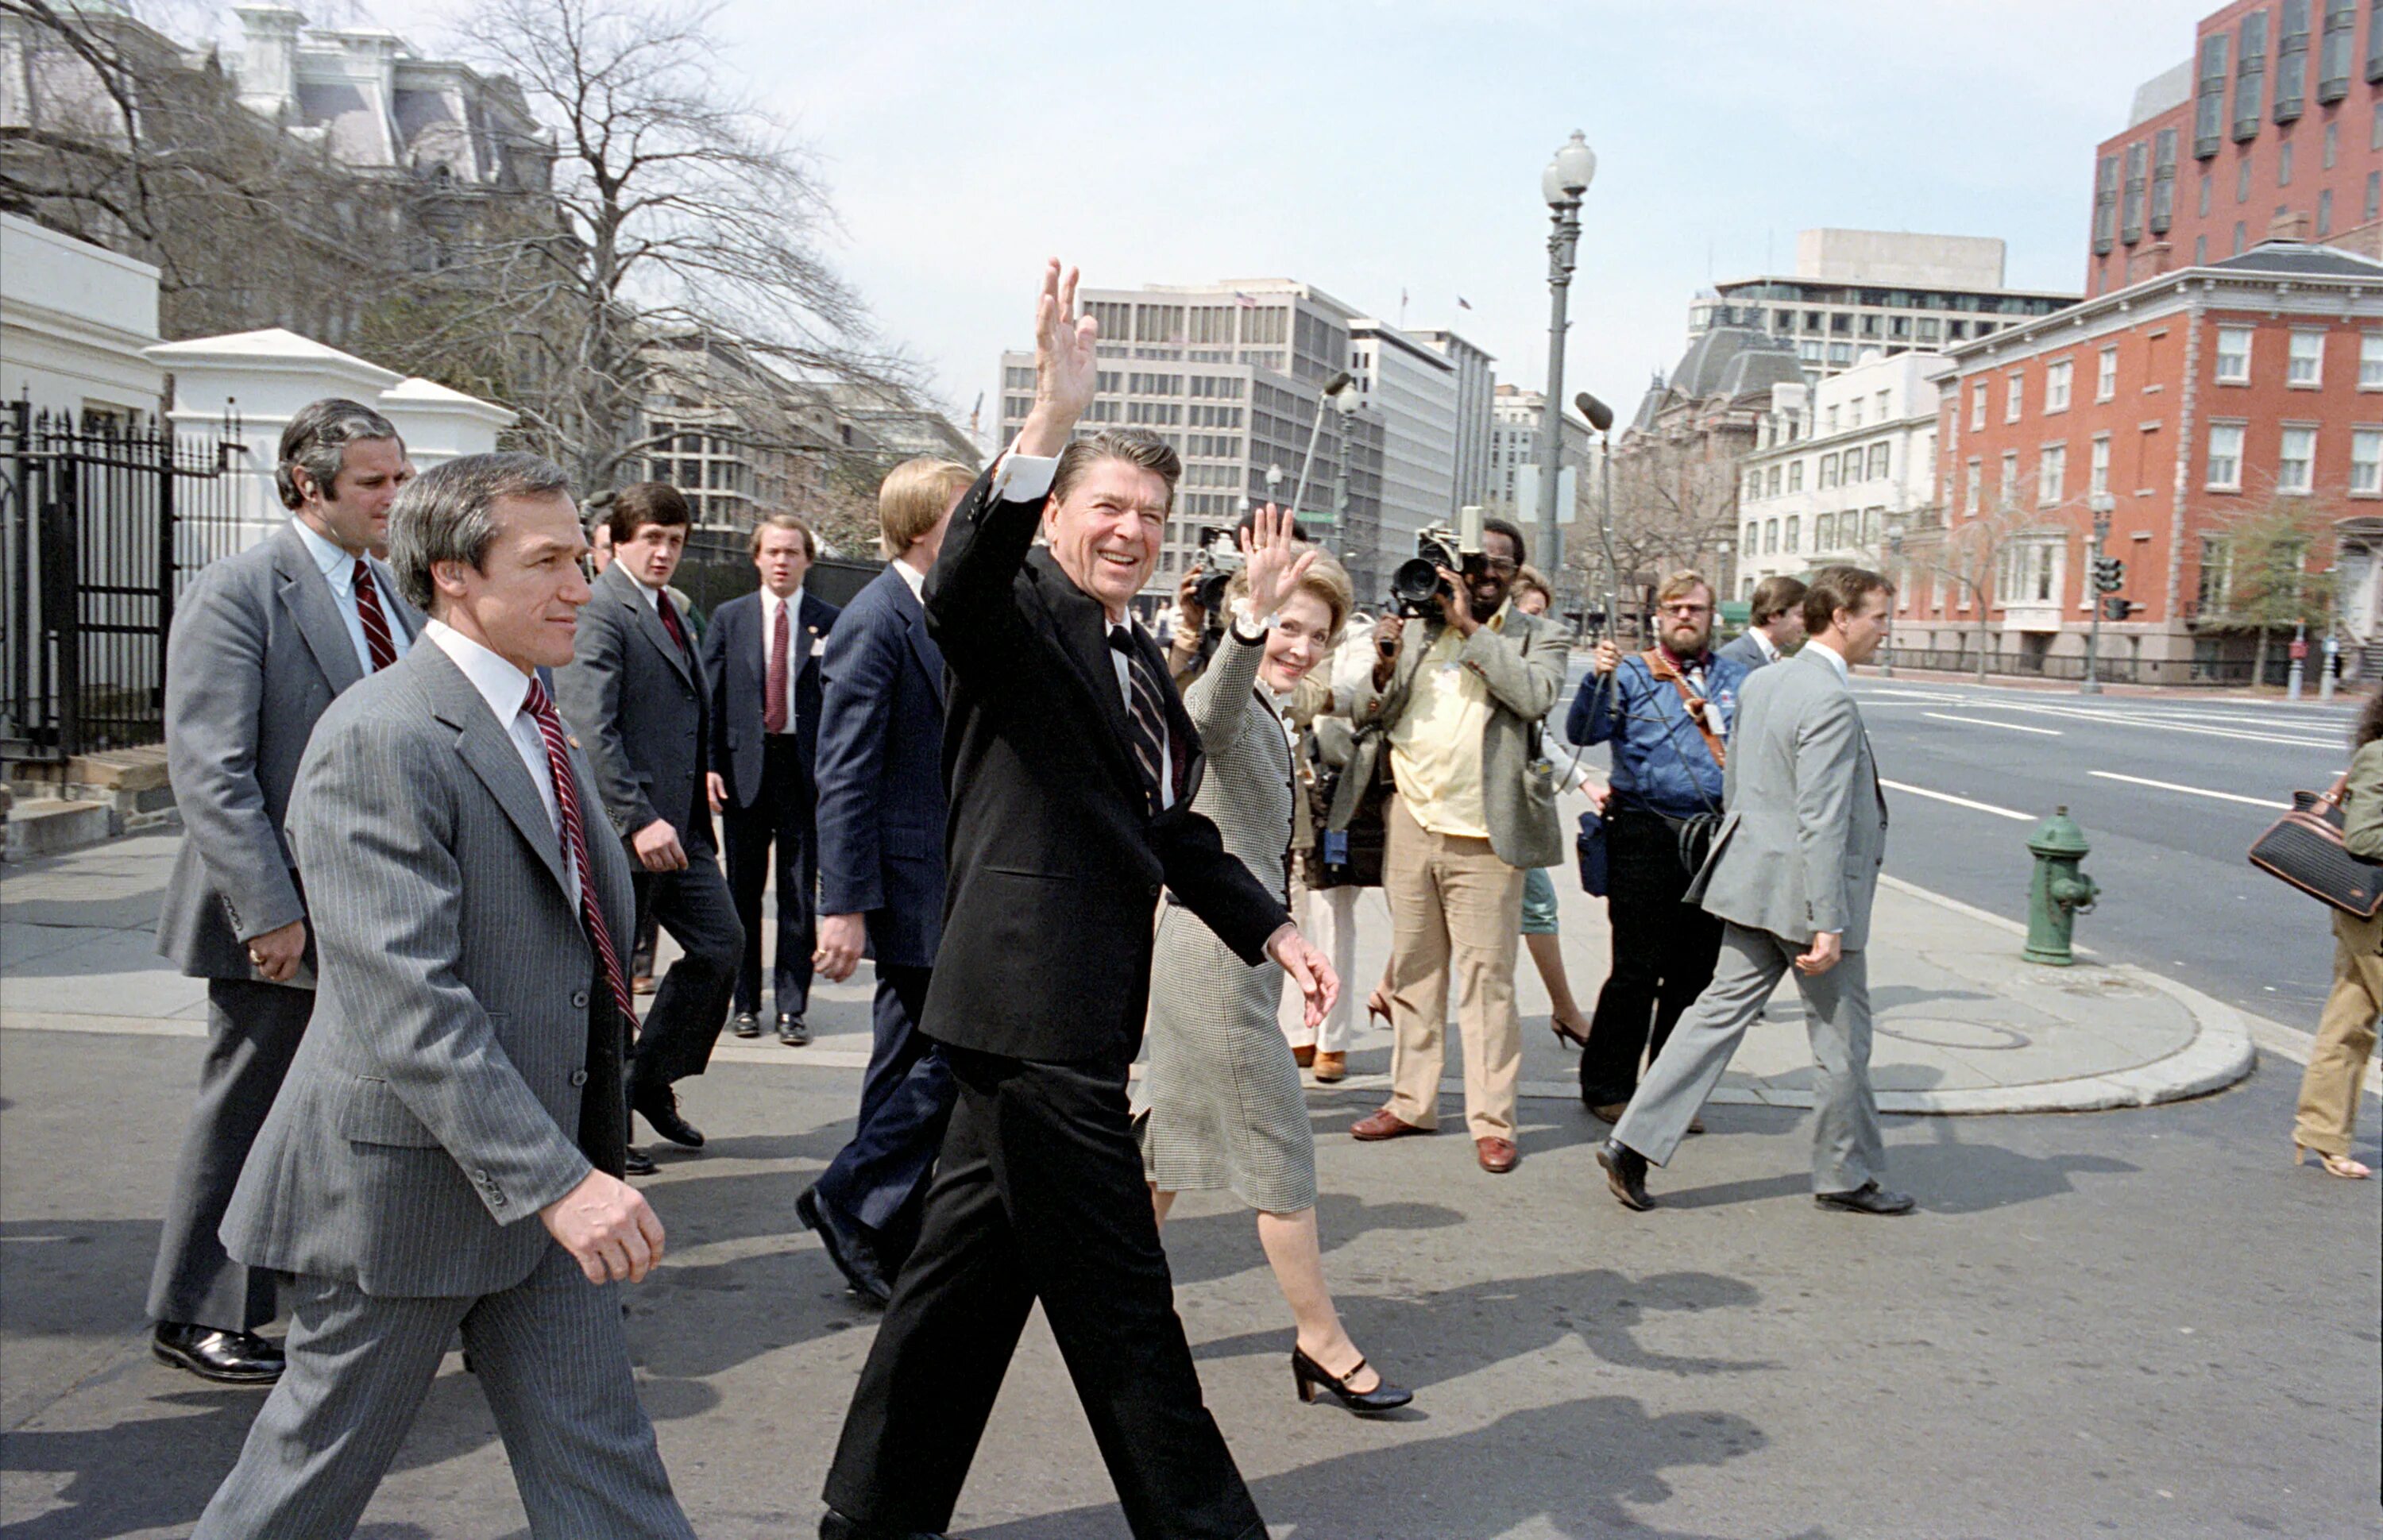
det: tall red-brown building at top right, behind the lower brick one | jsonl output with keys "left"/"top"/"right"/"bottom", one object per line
{"left": 2085, "top": 0, "right": 2383, "bottom": 295}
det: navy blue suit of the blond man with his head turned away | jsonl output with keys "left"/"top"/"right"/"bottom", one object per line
{"left": 815, "top": 567, "right": 953, "bottom": 1276}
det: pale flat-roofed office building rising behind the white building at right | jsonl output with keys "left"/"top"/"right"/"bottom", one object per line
{"left": 1687, "top": 229, "right": 2078, "bottom": 379}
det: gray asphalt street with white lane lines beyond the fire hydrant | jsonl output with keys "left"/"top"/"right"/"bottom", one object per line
{"left": 1558, "top": 665, "right": 2357, "bottom": 1030}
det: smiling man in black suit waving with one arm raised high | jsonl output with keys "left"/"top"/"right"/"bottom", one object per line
{"left": 820, "top": 262, "right": 1339, "bottom": 1540}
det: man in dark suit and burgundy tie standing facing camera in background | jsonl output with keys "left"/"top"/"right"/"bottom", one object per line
{"left": 703, "top": 512, "right": 841, "bottom": 1049}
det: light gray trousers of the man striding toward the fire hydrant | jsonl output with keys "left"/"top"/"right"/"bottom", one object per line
{"left": 1613, "top": 923, "right": 1887, "bottom": 1192}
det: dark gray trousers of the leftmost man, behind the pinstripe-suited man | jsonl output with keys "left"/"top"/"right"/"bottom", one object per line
{"left": 150, "top": 978, "right": 315, "bottom": 1333}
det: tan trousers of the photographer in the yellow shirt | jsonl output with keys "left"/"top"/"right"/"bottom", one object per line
{"left": 1382, "top": 797, "right": 1523, "bottom": 1140}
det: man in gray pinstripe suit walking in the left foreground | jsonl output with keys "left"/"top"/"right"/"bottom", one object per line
{"left": 195, "top": 455, "right": 693, "bottom": 1540}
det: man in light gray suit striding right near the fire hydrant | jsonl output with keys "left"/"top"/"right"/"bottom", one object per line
{"left": 1597, "top": 567, "right": 1911, "bottom": 1214}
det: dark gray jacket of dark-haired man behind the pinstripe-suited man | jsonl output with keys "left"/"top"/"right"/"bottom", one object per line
{"left": 555, "top": 562, "right": 720, "bottom": 854}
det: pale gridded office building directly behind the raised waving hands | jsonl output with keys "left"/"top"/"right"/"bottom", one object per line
{"left": 1001, "top": 279, "right": 1387, "bottom": 605}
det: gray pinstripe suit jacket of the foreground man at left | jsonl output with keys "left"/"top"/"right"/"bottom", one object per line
{"left": 222, "top": 643, "right": 634, "bottom": 1297}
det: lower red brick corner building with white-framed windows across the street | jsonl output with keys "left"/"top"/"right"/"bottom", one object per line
{"left": 1890, "top": 241, "right": 2383, "bottom": 681}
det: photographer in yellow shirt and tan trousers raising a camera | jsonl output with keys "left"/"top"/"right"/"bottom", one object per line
{"left": 1349, "top": 519, "right": 1566, "bottom": 1173}
